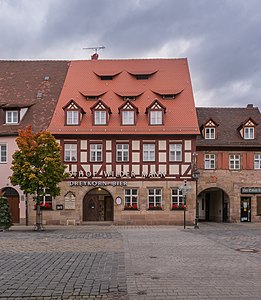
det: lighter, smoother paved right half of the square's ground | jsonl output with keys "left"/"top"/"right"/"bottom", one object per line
{"left": 120, "top": 223, "right": 261, "bottom": 300}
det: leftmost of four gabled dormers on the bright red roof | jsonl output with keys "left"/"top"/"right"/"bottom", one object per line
{"left": 63, "top": 99, "right": 85, "bottom": 126}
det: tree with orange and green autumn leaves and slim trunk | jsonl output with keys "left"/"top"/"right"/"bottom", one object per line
{"left": 10, "top": 126, "right": 67, "bottom": 230}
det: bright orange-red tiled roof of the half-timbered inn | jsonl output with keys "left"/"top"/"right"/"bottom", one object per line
{"left": 49, "top": 59, "right": 199, "bottom": 134}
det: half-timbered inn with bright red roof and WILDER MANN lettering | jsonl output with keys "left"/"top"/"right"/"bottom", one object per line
{"left": 42, "top": 59, "right": 199, "bottom": 224}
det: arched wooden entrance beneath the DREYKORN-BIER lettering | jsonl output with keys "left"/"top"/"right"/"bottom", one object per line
{"left": 83, "top": 188, "right": 113, "bottom": 222}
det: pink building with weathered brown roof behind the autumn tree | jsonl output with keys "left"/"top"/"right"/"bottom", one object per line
{"left": 0, "top": 61, "right": 69, "bottom": 223}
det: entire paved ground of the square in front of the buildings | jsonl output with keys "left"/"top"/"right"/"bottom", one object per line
{"left": 0, "top": 223, "right": 261, "bottom": 300}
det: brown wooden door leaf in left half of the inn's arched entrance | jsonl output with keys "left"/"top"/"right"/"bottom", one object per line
{"left": 83, "top": 195, "right": 99, "bottom": 221}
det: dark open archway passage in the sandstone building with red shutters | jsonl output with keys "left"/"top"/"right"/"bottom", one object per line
{"left": 199, "top": 187, "right": 229, "bottom": 222}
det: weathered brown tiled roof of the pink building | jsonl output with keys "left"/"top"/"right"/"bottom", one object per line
{"left": 0, "top": 61, "right": 69, "bottom": 135}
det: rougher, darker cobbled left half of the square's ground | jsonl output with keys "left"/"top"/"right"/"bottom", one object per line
{"left": 0, "top": 226, "right": 128, "bottom": 300}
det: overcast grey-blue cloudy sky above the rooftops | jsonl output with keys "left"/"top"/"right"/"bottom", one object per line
{"left": 0, "top": 0, "right": 261, "bottom": 108}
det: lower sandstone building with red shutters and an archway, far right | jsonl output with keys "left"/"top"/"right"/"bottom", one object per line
{"left": 197, "top": 104, "right": 261, "bottom": 222}
